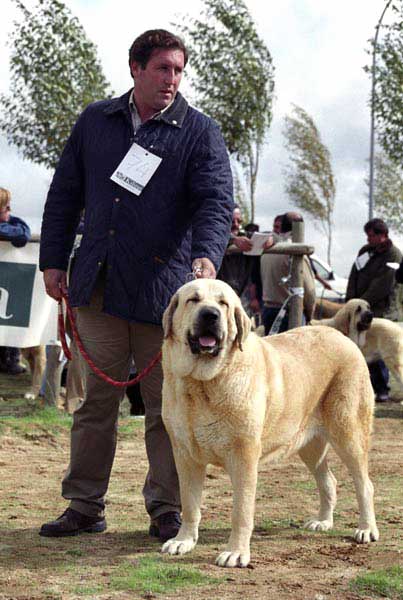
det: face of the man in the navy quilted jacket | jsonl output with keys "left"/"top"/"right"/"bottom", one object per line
{"left": 130, "top": 48, "right": 185, "bottom": 113}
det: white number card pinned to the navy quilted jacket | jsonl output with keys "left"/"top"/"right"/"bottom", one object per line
{"left": 111, "top": 143, "right": 162, "bottom": 196}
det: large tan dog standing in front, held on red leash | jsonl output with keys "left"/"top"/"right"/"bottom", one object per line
{"left": 162, "top": 279, "right": 379, "bottom": 567}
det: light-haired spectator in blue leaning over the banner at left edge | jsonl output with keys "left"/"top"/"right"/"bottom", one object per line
{"left": 0, "top": 187, "right": 31, "bottom": 375}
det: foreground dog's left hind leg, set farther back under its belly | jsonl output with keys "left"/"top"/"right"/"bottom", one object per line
{"left": 299, "top": 437, "right": 337, "bottom": 531}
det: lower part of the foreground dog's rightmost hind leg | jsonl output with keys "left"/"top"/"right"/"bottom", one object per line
{"left": 332, "top": 431, "right": 379, "bottom": 544}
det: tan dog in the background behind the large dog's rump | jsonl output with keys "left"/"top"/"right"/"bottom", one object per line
{"left": 311, "top": 298, "right": 403, "bottom": 386}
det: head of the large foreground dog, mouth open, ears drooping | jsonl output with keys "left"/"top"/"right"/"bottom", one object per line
{"left": 162, "top": 279, "right": 250, "bottom": 380}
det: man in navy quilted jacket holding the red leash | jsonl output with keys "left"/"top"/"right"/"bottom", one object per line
{"left": 40, "top": 30, "right": 233, "bottom": 540}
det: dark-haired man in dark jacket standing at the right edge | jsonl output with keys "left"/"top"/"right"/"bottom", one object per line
{"left": 346, "top": 219, "right": 402, "bottom": 402}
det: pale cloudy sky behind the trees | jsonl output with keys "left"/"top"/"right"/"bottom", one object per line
{"left": 0, "top": 0, "right": 403, "bottom": 276}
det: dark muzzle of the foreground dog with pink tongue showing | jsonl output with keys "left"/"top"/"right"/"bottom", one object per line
{"left": 187, "top": 306, "right": 223, "bottom": 357}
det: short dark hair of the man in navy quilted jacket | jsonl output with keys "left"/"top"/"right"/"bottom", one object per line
{"left": 129, "top": 29, "right": 188, "bottom": 69}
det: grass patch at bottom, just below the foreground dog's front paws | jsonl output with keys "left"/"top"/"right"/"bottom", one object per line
{"left": 111, "top": 557, "right": 222, "bottom": 594}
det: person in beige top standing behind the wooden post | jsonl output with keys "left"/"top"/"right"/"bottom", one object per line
{"left": 260, "top": 212, "right": 315, "bottom": 335}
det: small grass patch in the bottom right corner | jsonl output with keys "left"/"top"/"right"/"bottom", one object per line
{"left": 350, "top": 565, "right": 403, "bottom": 600}
